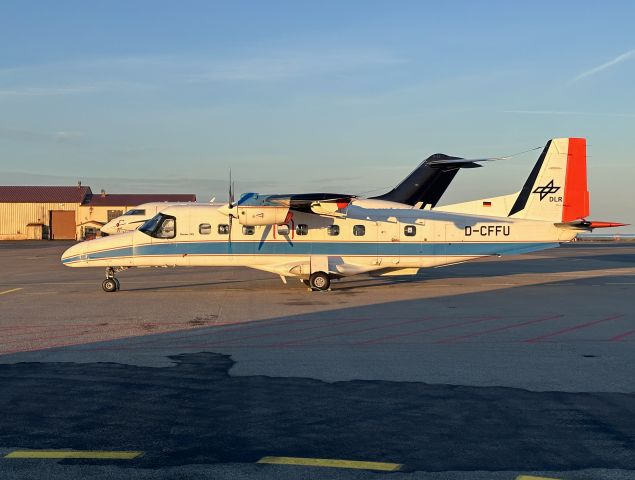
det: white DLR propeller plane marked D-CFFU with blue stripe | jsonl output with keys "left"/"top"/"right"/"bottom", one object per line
{"left": 61, "top": 138, "right": 624, "bottom": 292}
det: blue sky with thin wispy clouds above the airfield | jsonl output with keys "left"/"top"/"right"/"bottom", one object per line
{"left": 0, "top": 0, "right": 635, "bottom": 230}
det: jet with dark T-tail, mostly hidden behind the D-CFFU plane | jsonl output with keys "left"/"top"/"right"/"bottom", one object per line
{"left": 101, "top": 153, "right": 486, "bottom": 235}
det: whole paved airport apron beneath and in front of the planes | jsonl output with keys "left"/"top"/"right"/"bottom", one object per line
{"left": 0, "top": 242, "right": 635, "bottom": 480}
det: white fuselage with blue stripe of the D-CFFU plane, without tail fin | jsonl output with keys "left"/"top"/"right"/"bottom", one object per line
{"left": 62, "top": 202, "right": 576, "bottom": 278}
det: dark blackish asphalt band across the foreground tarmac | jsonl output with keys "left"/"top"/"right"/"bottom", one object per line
{"left": 0, "top": 352, "right": 635, "bottom": 471}
